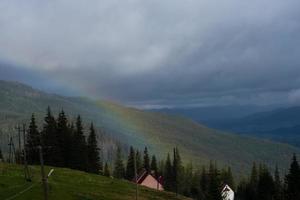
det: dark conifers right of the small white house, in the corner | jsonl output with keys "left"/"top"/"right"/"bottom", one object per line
{"left": 237, "top": 155, "right": 300, "bottom": 200}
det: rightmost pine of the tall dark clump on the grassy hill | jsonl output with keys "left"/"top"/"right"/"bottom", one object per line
{"left": 86, "top": 123, "right": 102, "bottom": 174}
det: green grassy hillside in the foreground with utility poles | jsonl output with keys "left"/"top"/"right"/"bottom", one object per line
{"left": 0, "top": 163, "right": 187, "bottom": 200}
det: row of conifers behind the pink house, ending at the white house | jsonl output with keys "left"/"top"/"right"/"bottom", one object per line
{"left": 109, "top": 147, "right": 234, "bottom": 200}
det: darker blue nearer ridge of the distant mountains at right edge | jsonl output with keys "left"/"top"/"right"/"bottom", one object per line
{"left": 206, "top": 107, "right": 300, "bottom": 147}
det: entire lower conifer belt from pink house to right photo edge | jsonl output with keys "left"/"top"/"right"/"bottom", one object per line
{"left": 111, "top": 147, "right": 300, "bottom": 200}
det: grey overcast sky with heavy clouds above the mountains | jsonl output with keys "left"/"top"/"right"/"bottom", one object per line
{"left": 0, "top": 0, "right": 300, "bottom": 107}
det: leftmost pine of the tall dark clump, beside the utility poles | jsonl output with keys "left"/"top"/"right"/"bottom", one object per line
{"left": 26, "top": 114, "right": 41, "bottom": 164}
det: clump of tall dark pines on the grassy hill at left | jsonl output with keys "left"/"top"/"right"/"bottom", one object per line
{"left": 25, "top": 107, "right": 102, "bottom": 173}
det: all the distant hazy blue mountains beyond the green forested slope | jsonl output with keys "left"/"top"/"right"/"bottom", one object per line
{"left": 154, "top": 105, "right": 300, "bottom": 147}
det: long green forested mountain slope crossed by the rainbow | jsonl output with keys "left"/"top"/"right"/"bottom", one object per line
{"left": 0, "top": 81, "right": 300, "bottom": 171}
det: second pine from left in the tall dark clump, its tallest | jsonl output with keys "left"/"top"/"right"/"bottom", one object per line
{"left": 42, "top": 106, "right": 63, "bottom": 166}
